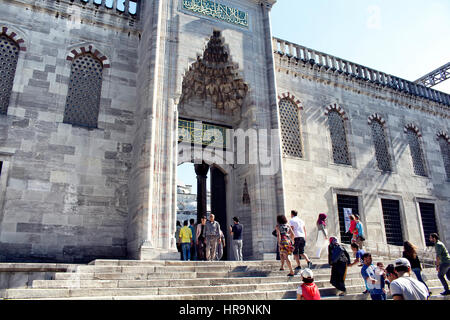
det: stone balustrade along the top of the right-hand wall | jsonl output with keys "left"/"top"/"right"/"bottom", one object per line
{"left": 273, "top": 38, "right": 450, "bottom": 106}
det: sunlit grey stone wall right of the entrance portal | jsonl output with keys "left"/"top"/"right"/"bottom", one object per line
{"left": 275, "top": 50, "right": 450, "bottom": 253}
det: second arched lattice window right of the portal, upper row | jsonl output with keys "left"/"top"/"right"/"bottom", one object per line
{"left": 328, "top": 110, "right": 351, "bottom": 165}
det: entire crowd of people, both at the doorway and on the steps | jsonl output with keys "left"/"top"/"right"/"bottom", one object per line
{"left": 175, "top": 210, "right": 450, "bottom": 300}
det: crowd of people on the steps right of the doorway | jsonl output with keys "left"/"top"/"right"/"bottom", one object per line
{"left": 273, "top": 210, "right": 450, "bottom": 300}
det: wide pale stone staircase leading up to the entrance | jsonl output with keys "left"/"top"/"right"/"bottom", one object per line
{"left": 0, "top": 257, "right": 448, "bottom": 300}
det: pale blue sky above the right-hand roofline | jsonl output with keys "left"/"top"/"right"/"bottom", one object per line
{"left": 271, "top": 0, "right": 450, "bottom": 93}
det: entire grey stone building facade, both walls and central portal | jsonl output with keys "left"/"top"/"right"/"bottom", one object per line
{"left": 0, "top": 0, "right": 450, "bottom": 262}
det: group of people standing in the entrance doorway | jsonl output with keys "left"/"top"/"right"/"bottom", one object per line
{"left": 175, "top": 214, "right": 243, "bottom": 261}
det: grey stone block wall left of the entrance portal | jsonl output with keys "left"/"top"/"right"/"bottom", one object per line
{"left": 0, "top": 1, "right": 138, "bottom": 262}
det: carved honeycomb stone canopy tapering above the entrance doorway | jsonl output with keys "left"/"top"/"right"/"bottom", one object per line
{"left": 180, "top": 31, "right": 248, "bottom": 113}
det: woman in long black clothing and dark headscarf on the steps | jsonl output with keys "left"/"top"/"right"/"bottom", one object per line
{"left": 328, "top": 237, "right": 350, "bottom": 296}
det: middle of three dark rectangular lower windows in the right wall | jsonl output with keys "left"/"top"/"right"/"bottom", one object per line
{"left": 381, "top": 199, "right": 403, "bottom": 246}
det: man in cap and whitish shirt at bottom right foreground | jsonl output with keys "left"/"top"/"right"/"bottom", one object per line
{"left": 391, "top": 258, "right": 428, "bottom": 300}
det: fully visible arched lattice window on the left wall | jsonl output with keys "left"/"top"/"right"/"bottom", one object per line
{"left": 64, "top": 53, "right": 103, "bottom": 128}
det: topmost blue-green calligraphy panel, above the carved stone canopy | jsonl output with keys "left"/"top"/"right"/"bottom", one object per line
{"left": 183, "top": 0, "right": 248, "bottom": 28}
